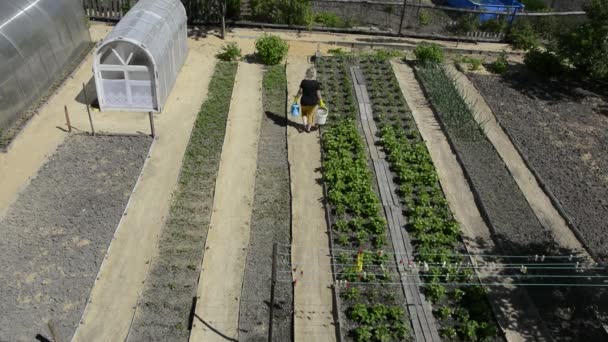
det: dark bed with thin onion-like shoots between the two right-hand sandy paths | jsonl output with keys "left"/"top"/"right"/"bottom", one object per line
{"left": 416, "top": 67, "right": 605, "bottom": 341}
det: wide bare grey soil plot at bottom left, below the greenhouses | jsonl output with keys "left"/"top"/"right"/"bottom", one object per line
{"left": 0, "top": 135, "right": 152, "bottom": 341}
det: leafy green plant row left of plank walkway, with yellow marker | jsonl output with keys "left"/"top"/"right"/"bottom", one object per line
{"left": 317, "top": 56, "right": 409, "bottom": 341}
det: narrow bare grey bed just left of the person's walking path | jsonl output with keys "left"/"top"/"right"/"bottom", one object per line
{"left": 239, "top": 65, "right": 293, "bottom": 342}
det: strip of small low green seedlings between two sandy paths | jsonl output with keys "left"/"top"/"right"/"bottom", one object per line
{"left": 129, "top": 62, "right": 237, "bottom": 341}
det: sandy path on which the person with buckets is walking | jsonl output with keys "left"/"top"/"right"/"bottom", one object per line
{"left": 287, "top": 57, "right": 336, "bottom": 342}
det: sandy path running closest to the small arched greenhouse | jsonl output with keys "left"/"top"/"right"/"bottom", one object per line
{"left": 74, "top": 27, "right": 215, "bottom": 341}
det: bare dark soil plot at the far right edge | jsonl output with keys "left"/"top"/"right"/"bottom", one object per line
{"left": 470, "top": 75, "right": 608, "bottom": 262}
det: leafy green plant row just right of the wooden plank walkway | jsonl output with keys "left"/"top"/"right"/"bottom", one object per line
{"left": 360, "top": 57, "right": 497, "bottom": 341}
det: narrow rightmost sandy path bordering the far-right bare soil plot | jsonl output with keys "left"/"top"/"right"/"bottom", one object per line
{"left": 446, "top": 65, "right": 584, "bottom": 253}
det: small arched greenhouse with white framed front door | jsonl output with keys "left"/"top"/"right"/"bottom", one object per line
{"left": 94, "top": 0, "right": 188, "bottom": 112}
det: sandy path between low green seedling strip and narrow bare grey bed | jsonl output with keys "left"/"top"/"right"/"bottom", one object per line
{"left": 190, "top": 63, "right": 263, "bottom": 342}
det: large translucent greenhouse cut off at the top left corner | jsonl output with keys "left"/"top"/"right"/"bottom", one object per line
{"left": 0, "top": 0, "right": 91, "bottom": 130}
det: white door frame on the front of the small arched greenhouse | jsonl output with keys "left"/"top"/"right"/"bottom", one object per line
{"left": 95, "top": 48, "right": 161, "bottom": 113}
